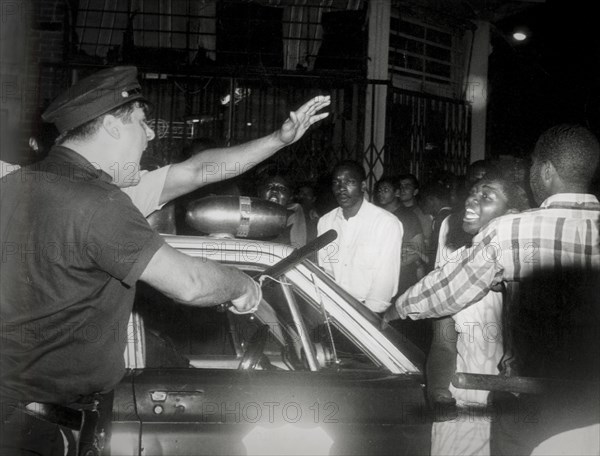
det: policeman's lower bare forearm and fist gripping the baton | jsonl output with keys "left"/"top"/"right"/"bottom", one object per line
{"left": 140, "top": 244, "right": 261, "bottom": 313}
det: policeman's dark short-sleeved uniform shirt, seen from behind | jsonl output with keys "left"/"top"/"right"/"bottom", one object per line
{"left": 0, "top": 147, "right": 164, "bottom": 404}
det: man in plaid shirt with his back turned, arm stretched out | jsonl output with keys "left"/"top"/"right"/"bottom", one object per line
{"left": 383, "top": 125, "right": 600, "bottom": 454}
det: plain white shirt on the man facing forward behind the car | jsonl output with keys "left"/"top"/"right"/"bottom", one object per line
{"left": 317, "top": 200, "right": 403, "bottom": 312}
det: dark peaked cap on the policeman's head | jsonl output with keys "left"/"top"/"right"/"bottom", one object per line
{"left": 42, "top": 66, "right": 144, "bottom": 133}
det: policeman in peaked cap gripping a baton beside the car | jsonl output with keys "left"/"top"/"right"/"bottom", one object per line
{"left": 0, "top": 67, "right": 261, "bottom": 455}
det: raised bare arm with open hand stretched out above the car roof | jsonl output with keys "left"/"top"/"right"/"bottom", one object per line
{"left": 160, "top": 96, "right": 330, "bottom": 204}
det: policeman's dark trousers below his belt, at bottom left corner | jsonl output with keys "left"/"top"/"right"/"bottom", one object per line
{"left": 0, "top": 404, "right": 76, "bottom": 456}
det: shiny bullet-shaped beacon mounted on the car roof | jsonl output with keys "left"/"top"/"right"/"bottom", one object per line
{"left": 185, "top": 196, "right": 287, "bottom": 239}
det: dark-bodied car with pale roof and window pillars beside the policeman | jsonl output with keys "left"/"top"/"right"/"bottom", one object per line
{"left": 104, "top": 236, "right": 431, "bottom": 456}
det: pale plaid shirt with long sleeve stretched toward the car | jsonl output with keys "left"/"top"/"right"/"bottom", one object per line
{"left": 384, "top": 193, "right": 600, "bottom": 321}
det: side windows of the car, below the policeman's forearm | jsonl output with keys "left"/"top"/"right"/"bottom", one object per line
{"left": 134, "top": 264, "right": 382, "bottom": 370}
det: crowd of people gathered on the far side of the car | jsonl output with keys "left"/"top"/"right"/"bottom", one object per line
{"left": 150, "top": 130, "right": 600, "bottom": 455}
